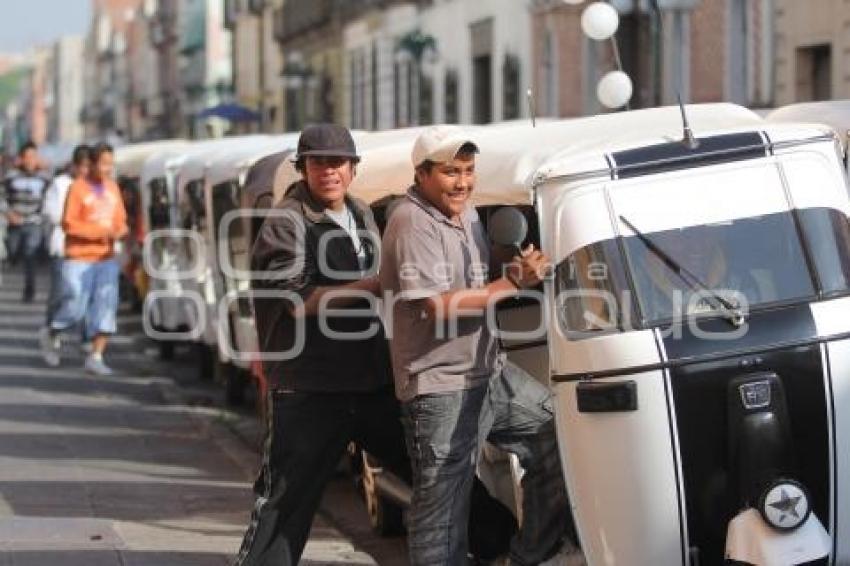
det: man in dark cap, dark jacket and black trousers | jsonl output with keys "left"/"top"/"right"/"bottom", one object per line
{"left": 230, "top": 124, "right": 408, "bottom": 566}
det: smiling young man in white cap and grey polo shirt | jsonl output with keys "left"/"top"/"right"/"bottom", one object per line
{"left": 380, "top": 126, "right": 575, "bottom": 566}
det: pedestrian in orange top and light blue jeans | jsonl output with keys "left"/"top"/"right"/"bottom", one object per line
{"left": 41, "top": 143, "right": 127, "bottom": 375}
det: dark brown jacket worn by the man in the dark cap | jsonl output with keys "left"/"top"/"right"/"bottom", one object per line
{"left": 251, "top": 181, "right": 392, "bottom": 392}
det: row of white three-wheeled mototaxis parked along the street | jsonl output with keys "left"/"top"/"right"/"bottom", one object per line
{"left": 118, "top": 100, "right": 850, "bottom": 565}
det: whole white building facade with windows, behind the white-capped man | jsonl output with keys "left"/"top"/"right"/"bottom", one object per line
{"left": 343, "top": 0, "right": 533, "bottom": 128}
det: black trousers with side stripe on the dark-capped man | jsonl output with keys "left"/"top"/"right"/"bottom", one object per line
{"left": 230, "top": 389, "right": 409, "bottom": 566}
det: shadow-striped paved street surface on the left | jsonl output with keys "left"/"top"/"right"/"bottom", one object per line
{"left": 0, "top": 272, "right": 375, "bottom": 566}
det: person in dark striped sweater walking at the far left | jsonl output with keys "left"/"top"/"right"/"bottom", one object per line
{"left": 0, "top": 142, "right": 48, "bottom": 303}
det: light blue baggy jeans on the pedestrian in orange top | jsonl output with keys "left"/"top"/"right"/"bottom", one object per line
{"left": 50, "top": 259, "right": 119, "bottom": 338}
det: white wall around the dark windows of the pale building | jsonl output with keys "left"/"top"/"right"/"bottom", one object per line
{"left": 343, "top": 0, "right": 533, "bottom": 128}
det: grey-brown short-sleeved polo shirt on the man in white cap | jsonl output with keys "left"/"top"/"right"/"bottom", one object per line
{"left": 380, "top": 187, "right": 503, "bottom": 401}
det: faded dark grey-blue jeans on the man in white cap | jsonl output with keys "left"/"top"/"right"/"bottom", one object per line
{"left": 402, "top": 363, "right": 575, "bottom": 566}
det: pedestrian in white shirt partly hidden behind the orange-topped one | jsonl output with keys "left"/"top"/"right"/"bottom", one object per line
{"left": 42, "top": 145, "right": 91, "bottom": 330}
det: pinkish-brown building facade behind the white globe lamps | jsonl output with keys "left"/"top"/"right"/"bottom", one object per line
{"left": 532, "top": 0, "right": 774, "bottom": 116}
